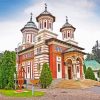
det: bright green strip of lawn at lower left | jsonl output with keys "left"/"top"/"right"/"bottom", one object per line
{"left": 0, "top": 90, "right": 44, "bottom": 97}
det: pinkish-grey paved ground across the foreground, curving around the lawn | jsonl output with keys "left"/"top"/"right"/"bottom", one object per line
{"left": 0, "top": 88, "right": 100, "bottom": 100}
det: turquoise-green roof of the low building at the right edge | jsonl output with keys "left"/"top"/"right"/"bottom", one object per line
{"left": 84, "top": 60, "right": 100, "bottom": 70}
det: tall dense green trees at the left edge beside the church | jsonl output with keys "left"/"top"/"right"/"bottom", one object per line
{"left": 0, "top": 51, "right": 16, "bottom": 89}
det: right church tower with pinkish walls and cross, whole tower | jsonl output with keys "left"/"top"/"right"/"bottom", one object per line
{"left": 60, "top": 16, "right": 78, "bottom": 45}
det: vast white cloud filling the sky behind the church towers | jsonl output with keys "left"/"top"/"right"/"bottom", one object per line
{"left": 0, "top": 0, "right": 100, "bottom": 52}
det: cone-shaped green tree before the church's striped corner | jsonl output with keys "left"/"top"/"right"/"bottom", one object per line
{"left": 40, "top": 63, "right": 52, "bottom": 88}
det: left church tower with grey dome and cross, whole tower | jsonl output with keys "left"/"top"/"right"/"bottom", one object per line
{"left": 21, "top": 13, "right": 38, "bottom": 49}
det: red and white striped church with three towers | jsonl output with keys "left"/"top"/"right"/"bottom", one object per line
{"left": 17, "top": 4, "right": 85, "bottom": 80}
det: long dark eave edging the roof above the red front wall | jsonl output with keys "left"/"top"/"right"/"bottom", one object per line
{"left": 45, "top": 38, "right": 84, "bottom": 50}
